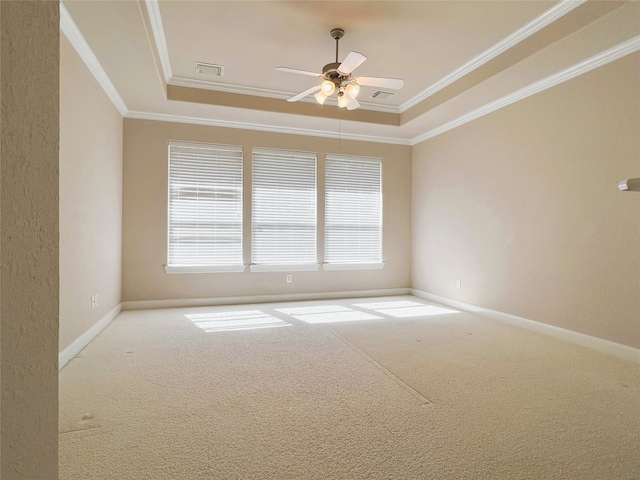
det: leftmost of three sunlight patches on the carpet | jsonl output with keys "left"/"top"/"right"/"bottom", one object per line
{"left": 185, "top": 310, "right": 291, "bottom": 333}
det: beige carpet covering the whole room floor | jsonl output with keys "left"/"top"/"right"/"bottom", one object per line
{"left": 60, "top": 297, "right": 640, "bottom": 480}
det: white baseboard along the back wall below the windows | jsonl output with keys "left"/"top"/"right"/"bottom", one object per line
{"left": 122, "top": 288, "right": 411, "bottom": 310}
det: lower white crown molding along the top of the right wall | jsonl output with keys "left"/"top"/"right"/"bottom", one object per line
{"left": 411, "top": 35, "right": 640, "bottom": 145}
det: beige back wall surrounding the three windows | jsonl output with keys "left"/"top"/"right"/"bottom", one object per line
{"left": 122, "top": 119, "right": 411, "bottom": 301}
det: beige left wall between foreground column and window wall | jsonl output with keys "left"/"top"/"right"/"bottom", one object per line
{"left": 60, "top": 36, "right": 123, "bottom": 350}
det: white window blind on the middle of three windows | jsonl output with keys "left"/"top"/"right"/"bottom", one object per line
{"left": 251, "top": 148, "right": 317, "bottom": 270}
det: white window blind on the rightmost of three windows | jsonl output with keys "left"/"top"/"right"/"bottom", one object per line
{"left": 324, "top": 155, "right": 382, "bottom": 268}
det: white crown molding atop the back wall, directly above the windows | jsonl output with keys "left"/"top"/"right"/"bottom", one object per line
{"left": 125, "top": 111, "right": 411, "bottom": 145}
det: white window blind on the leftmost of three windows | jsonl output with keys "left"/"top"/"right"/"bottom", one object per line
{"left": 167, "top": 142, "right": 243, "bottom": 273}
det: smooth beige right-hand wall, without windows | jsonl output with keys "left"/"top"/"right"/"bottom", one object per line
{"left": 412, "top": 54, "right": 640, "bottom": 347}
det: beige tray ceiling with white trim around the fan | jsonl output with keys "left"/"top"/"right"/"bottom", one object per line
{"left": 61, "top": 0, "right": 640, "bottom": 144}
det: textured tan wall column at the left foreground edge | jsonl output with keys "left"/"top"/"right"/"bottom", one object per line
{"left": 0, "top": 1, "right": 60, "bottom": 480}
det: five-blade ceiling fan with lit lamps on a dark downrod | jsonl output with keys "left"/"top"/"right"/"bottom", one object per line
{"left": 276, "top": 28, "right": 404, "bottom": 110}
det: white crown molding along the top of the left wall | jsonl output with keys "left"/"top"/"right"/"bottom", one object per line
{"left": 60, "top": 2, "right": 128, "bottom": 117}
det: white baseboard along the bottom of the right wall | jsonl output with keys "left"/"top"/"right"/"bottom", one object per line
{"left": 411, "top": 288, "right": 640, "bottom": 363}
